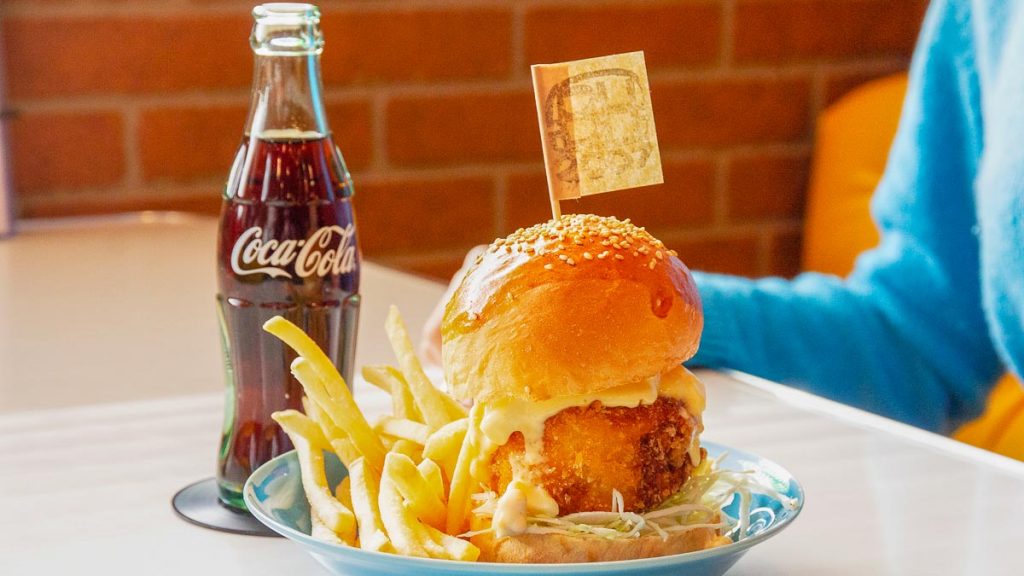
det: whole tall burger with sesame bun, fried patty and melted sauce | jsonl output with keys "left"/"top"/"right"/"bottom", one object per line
{"left": 441, "top": 214, "right": 726, "bottom": 563}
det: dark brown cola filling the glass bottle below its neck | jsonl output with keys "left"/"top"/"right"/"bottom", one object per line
{"left": 217, "top": 134, "right": 359, "bottom": 508}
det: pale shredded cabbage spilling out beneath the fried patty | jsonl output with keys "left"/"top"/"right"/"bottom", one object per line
{"left": 461, "top": 454, "right": 796, "bottom": 540}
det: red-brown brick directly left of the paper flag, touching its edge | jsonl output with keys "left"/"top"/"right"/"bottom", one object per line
{"left": 387, "top": 91, "right": 543, "bottom": 165}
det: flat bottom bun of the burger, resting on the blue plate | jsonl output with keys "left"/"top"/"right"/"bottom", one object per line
{"left": 472, "top": 528, "right": 732, "bottom": 564}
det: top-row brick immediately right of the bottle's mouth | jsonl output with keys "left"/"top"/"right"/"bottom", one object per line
{"left": 322, "top": 8, "right": 512, "bottom": 84}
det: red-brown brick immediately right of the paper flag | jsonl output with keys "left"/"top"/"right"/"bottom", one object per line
{"left": 651, "top": 78, "right": 812, "bottom": 150}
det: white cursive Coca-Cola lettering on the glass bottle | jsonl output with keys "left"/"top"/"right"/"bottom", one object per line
{"left": 231, "top": 223, "right": 356, "bottom": 278}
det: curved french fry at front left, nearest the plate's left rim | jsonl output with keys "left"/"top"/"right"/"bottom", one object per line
{"left": 272, "top": 410, "right": 355, "bottom": 543}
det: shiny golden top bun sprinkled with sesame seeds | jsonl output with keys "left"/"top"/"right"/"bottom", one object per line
{"left": 441, "top": 214, "right": 703, "bottom": 402}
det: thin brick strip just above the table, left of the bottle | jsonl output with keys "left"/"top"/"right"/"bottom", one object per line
{"left": 20, "top": 186, "right": 220, "bottom": 218}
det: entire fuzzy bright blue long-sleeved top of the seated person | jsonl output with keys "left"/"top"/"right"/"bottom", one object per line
{"left": 692, "top": 0, "right": 1024, "bottom": 431}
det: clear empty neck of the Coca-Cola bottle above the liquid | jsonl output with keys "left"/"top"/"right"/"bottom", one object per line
{"left": 246, "top": 52, "right": 330, "bottom": 139}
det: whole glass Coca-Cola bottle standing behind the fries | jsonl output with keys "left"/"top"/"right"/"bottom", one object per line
{"left": 217, "top": 4, "right": 360, "bottom": 509}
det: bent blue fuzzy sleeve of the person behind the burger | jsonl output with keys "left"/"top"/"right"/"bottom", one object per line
{"left": 691, "top": 0, "right": 1001, "bottom": 431}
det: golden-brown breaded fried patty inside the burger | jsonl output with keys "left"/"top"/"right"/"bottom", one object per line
{"left": 490, "top": 397, "right": 703, "bottom": 515}
